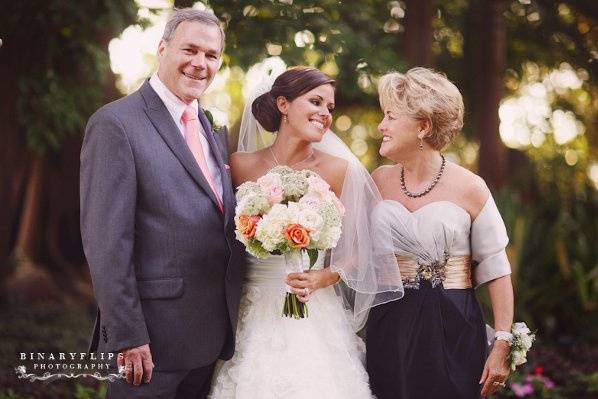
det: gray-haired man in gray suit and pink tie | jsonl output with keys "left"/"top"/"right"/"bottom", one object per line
{"left": 81, "top": 9, "right": 244, "bottom": 399}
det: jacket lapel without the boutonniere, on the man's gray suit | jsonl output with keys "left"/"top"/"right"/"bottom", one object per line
{"left": 139, "top": 81, "right": 220, "bottom": 213}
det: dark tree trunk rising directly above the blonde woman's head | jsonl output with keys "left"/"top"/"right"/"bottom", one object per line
{"left": 403, "top": 0, "right": 436, "bottom": 67}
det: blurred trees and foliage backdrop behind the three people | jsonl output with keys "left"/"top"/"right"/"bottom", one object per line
{"left": 0, "top": 0, "right": 598, "bottom": 396}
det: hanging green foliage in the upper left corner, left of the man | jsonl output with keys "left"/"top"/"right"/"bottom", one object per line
{"left": 0, "top": 0, "right": 137, "bottom": 152}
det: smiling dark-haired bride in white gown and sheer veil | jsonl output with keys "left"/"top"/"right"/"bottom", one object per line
{"left": 210, "top": 67, "right": 403, "bottom": 399}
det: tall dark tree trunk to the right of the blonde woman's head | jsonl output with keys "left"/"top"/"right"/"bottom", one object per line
{"left": 469, "top": 0, "right": 507, "bottom": 190}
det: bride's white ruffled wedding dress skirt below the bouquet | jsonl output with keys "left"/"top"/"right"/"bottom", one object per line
{"left": 210, "top": 256, "right": 372, "bottom": 399}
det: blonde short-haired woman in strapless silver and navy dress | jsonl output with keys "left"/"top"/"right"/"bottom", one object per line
{"left": 366, "top": 68, "right": 513, "bottom": 399}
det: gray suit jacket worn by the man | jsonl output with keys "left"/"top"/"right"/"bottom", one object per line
{"left": 80, "top": 81, "right": 245, "bottom": 370}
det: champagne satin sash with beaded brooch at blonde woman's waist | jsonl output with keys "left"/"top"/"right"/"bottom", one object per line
{"left": 397, "top": 255, "right": 472, "bottom": 289}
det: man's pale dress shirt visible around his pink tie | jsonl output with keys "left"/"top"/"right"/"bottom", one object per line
{"left": 150, "top": 73, "right": 222, "bottom": 198}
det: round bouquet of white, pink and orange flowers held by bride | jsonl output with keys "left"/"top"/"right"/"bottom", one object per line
{"left": 235, "top": 166, "right": 345, "bottom": 319}
